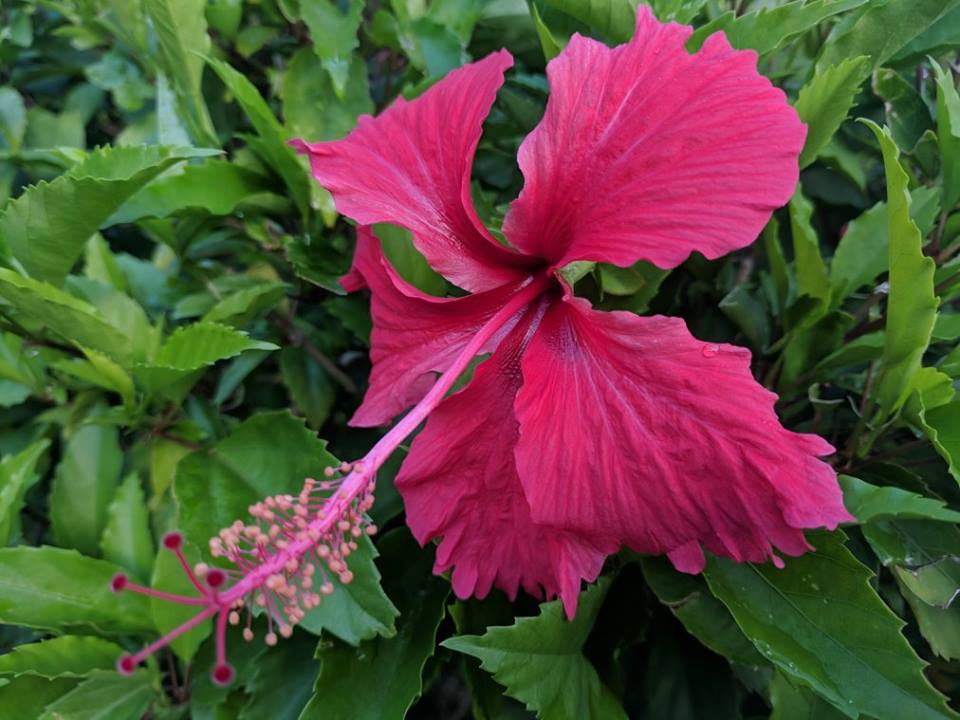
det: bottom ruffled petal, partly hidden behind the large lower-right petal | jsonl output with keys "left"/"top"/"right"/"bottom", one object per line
{"left": 396, "top": 300, "right": 616, "bottom": 617}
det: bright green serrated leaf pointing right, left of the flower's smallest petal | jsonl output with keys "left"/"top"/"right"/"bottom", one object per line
{"left": 134, "top": 322, "right": 277, "bottom": 392}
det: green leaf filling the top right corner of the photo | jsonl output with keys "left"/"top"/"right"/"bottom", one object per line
{"left": 817, "top": 0, "right": 960, "bottom": 71}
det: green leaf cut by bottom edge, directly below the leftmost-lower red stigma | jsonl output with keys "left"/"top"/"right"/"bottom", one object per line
{"left": 39, "top": 670, "right": 159, "bottom": 720}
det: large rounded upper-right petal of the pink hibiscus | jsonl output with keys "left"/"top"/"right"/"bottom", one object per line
{"left": 504, "top": 5, "right": 806, "bottom": 268}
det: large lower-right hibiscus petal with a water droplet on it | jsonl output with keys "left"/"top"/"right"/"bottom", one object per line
{"left": 516, "top": 298, "right": 851, "bottom": 572}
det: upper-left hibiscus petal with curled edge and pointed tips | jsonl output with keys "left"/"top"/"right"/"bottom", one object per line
{"left": 296, "top": 50, "right": 524, "bottom": 291}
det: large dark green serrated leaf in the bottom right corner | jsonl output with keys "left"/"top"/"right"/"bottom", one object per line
{"left": 705, "top": 532, "right": 954, "bottom": 718}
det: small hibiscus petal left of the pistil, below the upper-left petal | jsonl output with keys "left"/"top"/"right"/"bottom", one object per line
{"left": 341, "top": 227, "right": 516, "bottom": 427}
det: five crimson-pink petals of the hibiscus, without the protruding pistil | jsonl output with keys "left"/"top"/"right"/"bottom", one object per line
{"left": 296, "top": 6, "right": 851, "bottom": 616}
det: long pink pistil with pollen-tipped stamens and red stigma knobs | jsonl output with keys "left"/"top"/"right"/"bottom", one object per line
{"left": 111, "top": 274, "right": 551, "bottom": 685}
